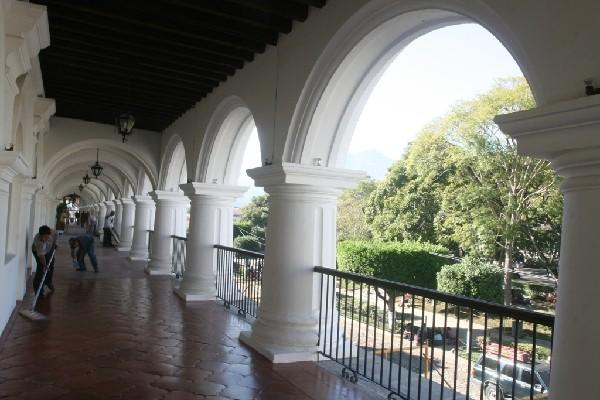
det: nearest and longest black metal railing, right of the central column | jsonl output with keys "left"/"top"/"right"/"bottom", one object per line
{"left": 314, "top": 267, "right": 554, "bottom": 400}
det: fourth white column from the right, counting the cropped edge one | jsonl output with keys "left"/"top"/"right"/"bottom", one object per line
{"left": 146, "top": 190, "right": 190, "bottom": 275}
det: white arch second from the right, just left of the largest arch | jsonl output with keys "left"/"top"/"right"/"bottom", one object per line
{"left": 196, "top": 96, "right": 262, "bottom": 185}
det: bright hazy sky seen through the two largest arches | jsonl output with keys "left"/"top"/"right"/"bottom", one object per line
{"left": 239, "top": 24, "right": 522, "bottom": 185}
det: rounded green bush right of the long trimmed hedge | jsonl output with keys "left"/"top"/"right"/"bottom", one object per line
{"left": 437, "top": 257, "right": 504, "bottom": 303}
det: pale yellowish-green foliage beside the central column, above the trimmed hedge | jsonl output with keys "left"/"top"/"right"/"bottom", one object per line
{"left": 337, "top": 180, "right": 376, "bottom": 241}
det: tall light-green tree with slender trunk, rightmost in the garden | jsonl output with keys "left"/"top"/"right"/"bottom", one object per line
{"left": 437, "top": 79, "right": 561, "bottom": 304}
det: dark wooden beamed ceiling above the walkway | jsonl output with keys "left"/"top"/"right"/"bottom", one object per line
{"left": 32, "top": 0, "right": 326, "bottom": 131}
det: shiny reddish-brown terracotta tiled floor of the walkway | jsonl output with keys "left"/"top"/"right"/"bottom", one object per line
{"left": 0, "top": 231, "right": 365, "bottom": 400}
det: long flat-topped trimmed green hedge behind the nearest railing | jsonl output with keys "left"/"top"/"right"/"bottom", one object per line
{"left": 337, "top": 241, "right": 452, "bottom": 289}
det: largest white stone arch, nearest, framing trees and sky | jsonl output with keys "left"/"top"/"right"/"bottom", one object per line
{"left": 283, "top": 0, "right": 543, "bottom": 167}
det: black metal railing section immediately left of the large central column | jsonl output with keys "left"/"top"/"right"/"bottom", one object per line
{"left": 215, "top": 245, "right": 264, "bottom": 317}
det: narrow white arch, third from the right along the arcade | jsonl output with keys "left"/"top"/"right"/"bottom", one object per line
{"left": 159, "top": 135, "right": 187, "bottom": 192}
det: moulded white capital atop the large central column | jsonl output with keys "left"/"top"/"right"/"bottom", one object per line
{"left": 247, "top": 162, "right": 367, "bottom": 193}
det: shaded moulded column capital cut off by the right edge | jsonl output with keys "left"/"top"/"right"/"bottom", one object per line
{"left": 494, "top": 96, "right": 600, "bottom": 192}
